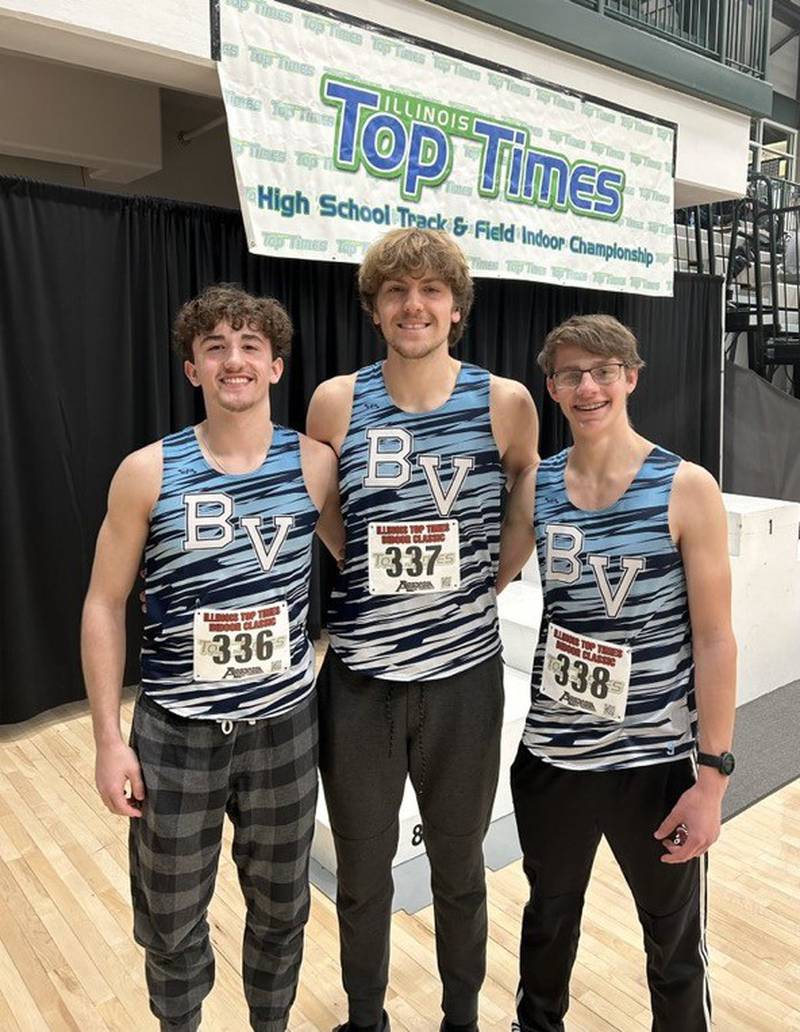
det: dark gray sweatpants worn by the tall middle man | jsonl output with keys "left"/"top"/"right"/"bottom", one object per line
{"left": 317, "top": 649, "right": 503, "bottom": 1026}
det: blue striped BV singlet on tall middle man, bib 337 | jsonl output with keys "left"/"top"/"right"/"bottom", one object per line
{"left": 328, "top": 361, "right": 505, "bottom": 681}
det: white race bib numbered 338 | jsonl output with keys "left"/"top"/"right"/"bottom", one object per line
{"left": 541, "top": 623, "right": 631, "bottom": 723}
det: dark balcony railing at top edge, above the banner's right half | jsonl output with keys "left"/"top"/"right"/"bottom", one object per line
{"left": 573, "top": 0, "right": 771, "bottom": 78}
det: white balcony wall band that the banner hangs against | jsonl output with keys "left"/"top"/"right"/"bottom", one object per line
{"left": 0, "top": 0, "right": 749, "bottom": 204}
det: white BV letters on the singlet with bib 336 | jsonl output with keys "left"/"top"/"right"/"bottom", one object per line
{"left": 184, "top": 491, "right": 294, "bottom": 573}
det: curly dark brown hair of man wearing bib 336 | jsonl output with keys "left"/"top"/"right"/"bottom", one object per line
{"left": 172, "top": 283, "right": 292, "bottom": 362}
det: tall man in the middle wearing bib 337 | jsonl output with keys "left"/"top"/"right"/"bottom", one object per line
{"left": 308, "top": 229, "right": 537, "bottom": 1032}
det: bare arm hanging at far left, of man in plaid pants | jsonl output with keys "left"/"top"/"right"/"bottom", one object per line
{"left": 81, "top": 443, "right": 161, "bottom": 817}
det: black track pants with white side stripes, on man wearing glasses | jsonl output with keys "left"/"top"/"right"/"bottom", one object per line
{"left": 511, "top": 745, "right": 711, "bottom": 1032}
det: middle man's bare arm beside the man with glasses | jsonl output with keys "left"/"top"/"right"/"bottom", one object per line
{"left": 490, "top": 376, "right": 539, "bottom": 591}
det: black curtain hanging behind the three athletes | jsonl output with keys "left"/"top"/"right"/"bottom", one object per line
{"left": 0, "top": 178, "right": 722, "bottom": 723}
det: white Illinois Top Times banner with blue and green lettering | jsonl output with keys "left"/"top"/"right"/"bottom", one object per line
{"left": 219, "top": 0, "right": 675, "bottom": 295}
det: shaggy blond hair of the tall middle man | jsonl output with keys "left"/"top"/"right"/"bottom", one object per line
{"left": 358, "top": 229, "right": 475, "bottom": 347}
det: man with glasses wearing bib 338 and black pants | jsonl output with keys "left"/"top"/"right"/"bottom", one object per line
{"left": 507, "top": 315, "right": 736, "bottom": 1032}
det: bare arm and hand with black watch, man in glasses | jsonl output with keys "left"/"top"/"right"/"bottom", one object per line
{"left": 655, "top": 462, "right": 736, "bottom": 864}
